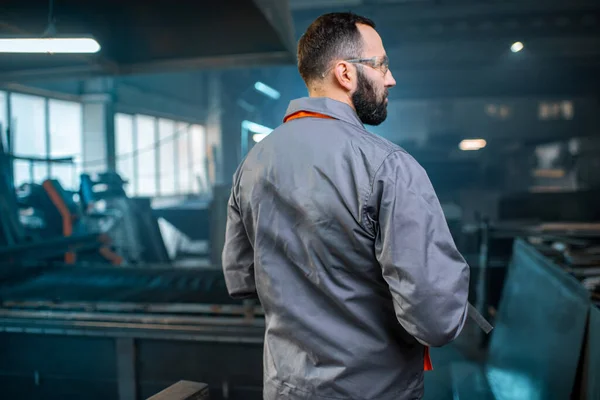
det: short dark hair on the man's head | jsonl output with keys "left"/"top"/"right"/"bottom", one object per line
{"left": 298, "top": 12, "right": 375, "bottom": 85}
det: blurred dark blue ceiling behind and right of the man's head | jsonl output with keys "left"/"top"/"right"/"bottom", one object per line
{"left": 290, "top": 0, "right": 600, "bottom": 97}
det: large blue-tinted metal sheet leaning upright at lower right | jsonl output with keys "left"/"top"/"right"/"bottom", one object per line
{"left": 486, "top": 239, "right": 590, "bottom": 400}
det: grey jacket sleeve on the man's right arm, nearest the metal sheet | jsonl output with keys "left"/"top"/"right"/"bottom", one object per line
{"left": 369, "top": 151, "right": 469, "bottom": 347}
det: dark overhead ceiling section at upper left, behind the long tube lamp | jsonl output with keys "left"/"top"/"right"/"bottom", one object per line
{"left": 0, "top": 0, "right": 295, "bottom": 81}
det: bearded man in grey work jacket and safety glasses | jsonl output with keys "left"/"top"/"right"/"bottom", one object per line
{"left": 223, "top": 13, "right": 469, "bottom": 400}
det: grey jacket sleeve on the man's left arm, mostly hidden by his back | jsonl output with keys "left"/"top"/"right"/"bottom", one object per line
{"left": 222, "top": 180, "right": 257, "bottom": 299}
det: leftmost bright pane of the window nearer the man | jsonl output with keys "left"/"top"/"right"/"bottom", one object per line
{"left": 115, "top": 114, "right": 136, "bottom": 196}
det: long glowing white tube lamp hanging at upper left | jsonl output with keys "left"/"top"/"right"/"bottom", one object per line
{"left": 0, "top": 37, "right": 100, "bottom": 54}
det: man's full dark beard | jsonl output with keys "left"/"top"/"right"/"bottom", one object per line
{"left": 352, "top": 69, "right": 387, "bottom": 126}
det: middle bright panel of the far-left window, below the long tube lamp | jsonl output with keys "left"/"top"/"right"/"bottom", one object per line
{"left": 10, "top": 93, "right": 49, "bottom": 187}
